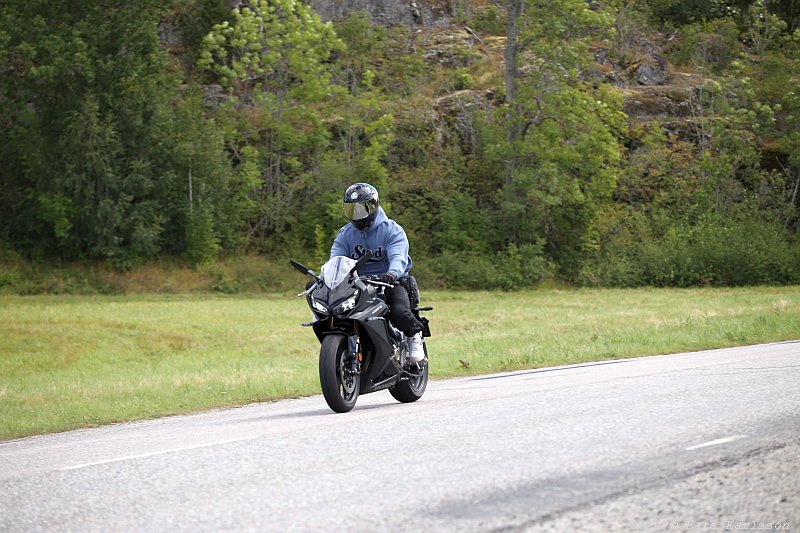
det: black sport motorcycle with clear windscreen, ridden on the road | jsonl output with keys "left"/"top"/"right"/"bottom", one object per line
{"left": 291, "top": 253, "right": 433, "bottom": 413}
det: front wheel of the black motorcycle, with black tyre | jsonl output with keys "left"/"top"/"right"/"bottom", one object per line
{"left": 319, "top": 335, "right": 361, "bottom": 413}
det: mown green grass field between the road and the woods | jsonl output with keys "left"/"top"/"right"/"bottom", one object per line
{"left": 0, "top": 287, "right": 800, "bottom": 439}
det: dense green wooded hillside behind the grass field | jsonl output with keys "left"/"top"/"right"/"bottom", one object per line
{"left": 0, "top": 0, "right": 800, "bottom": 289}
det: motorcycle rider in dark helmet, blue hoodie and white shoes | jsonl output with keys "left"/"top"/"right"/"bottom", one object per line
{"left": 331, "top": 183, "right": 425, "bottom": 363}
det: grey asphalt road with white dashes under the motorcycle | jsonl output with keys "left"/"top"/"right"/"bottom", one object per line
{"left": 0, "top": 342, "right": 800, "bottom": 532}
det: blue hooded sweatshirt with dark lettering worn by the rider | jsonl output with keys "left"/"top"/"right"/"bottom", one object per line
{"left": 331, "top": 207, "right": 411, "bottom": 279}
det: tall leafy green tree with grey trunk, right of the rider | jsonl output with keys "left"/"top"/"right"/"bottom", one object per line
{"left": 496, "top": 0, "right": 622, "bottom": 269}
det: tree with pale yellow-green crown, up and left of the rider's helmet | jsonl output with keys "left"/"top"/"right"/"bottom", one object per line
{"left": 199, "top": 0, "right": 342, "bottom": 241}
